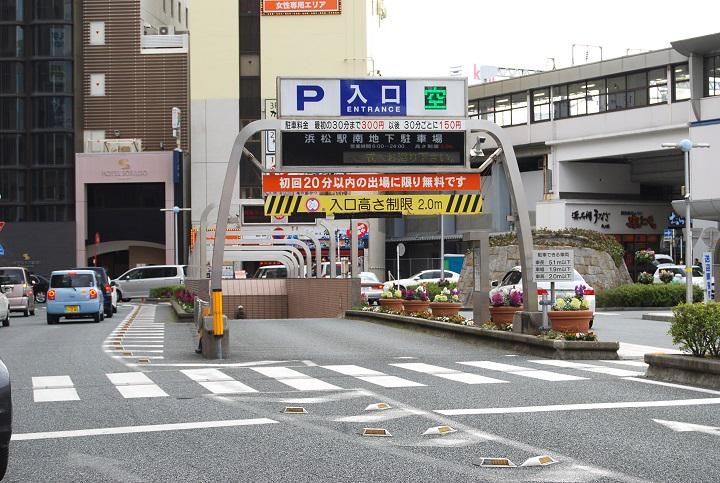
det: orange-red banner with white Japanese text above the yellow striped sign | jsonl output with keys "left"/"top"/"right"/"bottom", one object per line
{"left": 263, "top": 173, "right": 480, "bottom": 193}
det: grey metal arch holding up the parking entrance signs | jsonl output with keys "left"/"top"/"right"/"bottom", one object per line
{"left": 210, "top": 119, "right": 538, "bottom": 337}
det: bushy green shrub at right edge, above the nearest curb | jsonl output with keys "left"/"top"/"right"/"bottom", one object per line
{"left": 668, "top": 302, "right": 720, "bottom": 357}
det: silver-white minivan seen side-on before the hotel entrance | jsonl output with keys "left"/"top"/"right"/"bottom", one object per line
{"left": 110, "top": 265, "right": 187, "bottom": 302}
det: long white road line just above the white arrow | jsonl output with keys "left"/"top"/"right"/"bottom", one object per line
{"left": 434, "top": 398, "right": 720, "bottom": 416}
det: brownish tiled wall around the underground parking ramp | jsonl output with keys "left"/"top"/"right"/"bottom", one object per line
{"left": 185, "top": 278, "right": 360, "bottom": 319}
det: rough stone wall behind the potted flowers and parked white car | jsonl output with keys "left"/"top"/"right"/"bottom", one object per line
{"left": 460, "top": 245, "right": 632, "bottom": 304}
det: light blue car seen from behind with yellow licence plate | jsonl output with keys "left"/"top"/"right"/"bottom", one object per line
{"left": 47, "top": 270, "right": 105, "bottom": 324}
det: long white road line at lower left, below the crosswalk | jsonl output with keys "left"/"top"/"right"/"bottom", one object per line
{"left": 12, "top": 418, "right": 277, "bottom": 441}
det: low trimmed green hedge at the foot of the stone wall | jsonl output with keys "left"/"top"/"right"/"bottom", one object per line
{"left": 595, "top": 283, "right": 703, "bottom": 307}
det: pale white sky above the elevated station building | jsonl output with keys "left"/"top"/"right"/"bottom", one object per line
{"left": 373, "top": 0, "right": 720, "bottom": 78}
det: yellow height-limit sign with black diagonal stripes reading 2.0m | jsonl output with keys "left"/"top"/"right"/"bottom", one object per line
{"left": 265, "top": 194, "right": 483, "bottom": 216}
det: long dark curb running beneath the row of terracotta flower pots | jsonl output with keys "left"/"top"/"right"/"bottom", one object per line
{"left": 345, "top": 310, "right": 620, "bottom": 360}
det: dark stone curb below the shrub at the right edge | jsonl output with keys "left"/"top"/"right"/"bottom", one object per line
{"left": 645, "top": 354, "right": 720, "bottom": 389}
